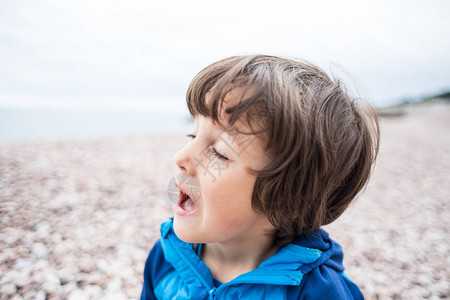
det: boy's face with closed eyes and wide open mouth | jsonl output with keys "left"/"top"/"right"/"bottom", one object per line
{"left": 174, "top": 91, "right": 273, "bottom": 243}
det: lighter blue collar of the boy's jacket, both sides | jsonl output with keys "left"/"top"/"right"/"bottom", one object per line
{"left": 161, "top": 219, "right": 342, "bottom": 289}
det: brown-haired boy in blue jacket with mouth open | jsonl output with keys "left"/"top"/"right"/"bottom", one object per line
{"left": 141, "top": 55, "right": 379, "bottom": 299}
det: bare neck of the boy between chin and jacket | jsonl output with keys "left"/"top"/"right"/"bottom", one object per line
{"left": 202, "top": 236, "right": 277, "bottom": 283}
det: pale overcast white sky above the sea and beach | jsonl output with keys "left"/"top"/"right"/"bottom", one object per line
{"left": 0, "top": 0, "right": 450, "bottom": 111}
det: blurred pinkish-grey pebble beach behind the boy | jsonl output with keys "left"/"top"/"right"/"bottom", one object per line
{"left": 0, "top": 101, "right": 450, "bottom": 300}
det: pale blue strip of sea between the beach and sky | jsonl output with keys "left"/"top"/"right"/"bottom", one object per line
{"left": 0, "top": 108, "right": 192, "bottom": 143}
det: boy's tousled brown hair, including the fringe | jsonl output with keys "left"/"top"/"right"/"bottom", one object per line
{"left": 187, "top": 55, "right": 379, "bottom": 245}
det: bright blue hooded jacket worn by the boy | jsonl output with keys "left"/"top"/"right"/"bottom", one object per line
{"left": 141, "top": 220, "right": 364, "bottom": 300}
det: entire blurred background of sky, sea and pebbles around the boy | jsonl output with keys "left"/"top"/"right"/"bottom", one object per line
{"left": 0, "top": 0, "right": 450, "bottom": 300}
